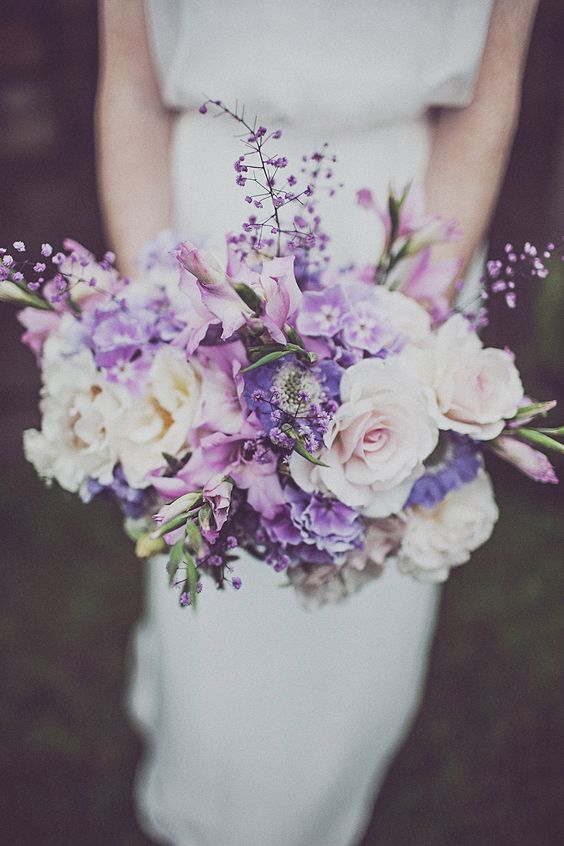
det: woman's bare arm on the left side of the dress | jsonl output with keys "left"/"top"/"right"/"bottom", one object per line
{"left": 96, "top": 0, "right": 172, "bottom": 274}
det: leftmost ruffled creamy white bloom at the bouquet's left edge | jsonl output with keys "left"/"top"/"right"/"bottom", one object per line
{"left": 24, "top": 336, "right": 121, "bottom": 492}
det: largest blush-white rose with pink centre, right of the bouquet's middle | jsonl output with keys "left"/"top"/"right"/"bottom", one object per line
{"left": 290, "top": 355, "right": 438, "bottom": 517}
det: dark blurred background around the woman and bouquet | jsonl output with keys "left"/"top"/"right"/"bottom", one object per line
{"left": 0, "top": 0, "right": 564, "bottom": 846}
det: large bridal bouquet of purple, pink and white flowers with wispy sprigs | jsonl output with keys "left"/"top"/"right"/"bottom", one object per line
{"left": 0, "top": 101, "right": 564, "bottom": 605}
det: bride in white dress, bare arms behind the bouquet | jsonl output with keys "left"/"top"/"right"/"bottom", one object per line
{"left": 97, "top": 0, "right": 536, "bottom": 846}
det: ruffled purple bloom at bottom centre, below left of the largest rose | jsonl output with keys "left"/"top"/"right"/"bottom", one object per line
{"left": 264, "top": 483, "right": 365, "bottom": 564}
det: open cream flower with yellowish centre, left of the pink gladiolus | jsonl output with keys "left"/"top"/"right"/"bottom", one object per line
{"left": 116, "top": 346, "right": 201, "bottom": 488}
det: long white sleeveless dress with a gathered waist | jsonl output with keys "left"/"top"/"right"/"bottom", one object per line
{"left": 129, "top": 0, "right": 493, "bottom": 846}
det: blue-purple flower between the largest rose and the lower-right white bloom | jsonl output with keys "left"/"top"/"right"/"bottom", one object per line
{"left": 405, "top": 432, "right": 482, "bottom": 508}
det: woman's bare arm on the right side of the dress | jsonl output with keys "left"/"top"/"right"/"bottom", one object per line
{"left": 426, "top": 0, "right": 538, "bottom": 274}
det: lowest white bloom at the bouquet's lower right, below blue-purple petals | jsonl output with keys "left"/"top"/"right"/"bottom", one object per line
{"left": 398, "top": 470, "right": 498, "bottom": 582}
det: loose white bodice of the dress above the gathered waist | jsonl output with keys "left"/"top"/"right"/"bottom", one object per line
{"left": 146, "top": 0, "right": 493, "bottom": 134}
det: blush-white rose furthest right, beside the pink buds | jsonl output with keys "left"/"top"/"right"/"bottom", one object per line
{"left": 431, "top": 314, "right": 523, "bottom": 440}
